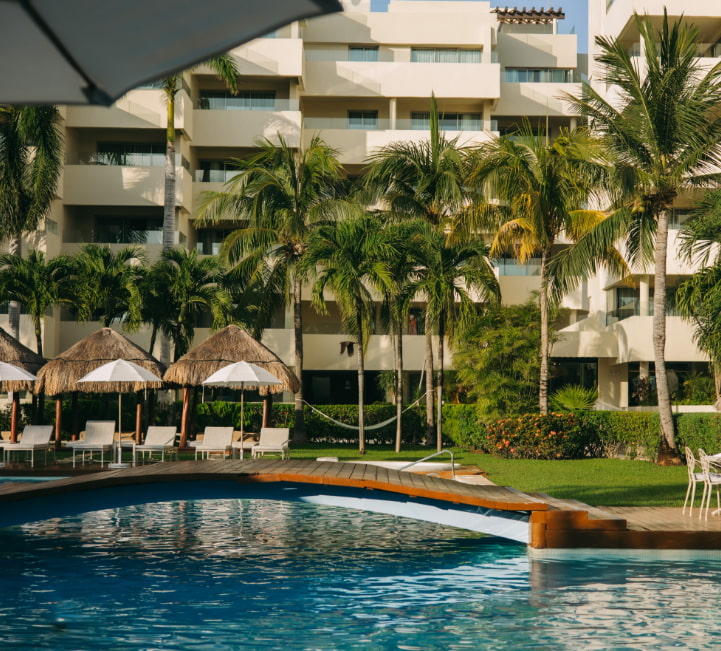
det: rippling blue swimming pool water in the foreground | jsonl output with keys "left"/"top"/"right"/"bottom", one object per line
{"left": 0, "top": 500, "right": 721, "bottom": 651}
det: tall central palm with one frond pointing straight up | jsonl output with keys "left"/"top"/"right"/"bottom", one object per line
{"left": 364, "top": 96, "right": 470, "bottom": 439}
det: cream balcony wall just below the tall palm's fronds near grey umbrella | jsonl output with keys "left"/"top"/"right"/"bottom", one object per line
{"left": 193, "top": 100, "right": 301, "bottom": 147}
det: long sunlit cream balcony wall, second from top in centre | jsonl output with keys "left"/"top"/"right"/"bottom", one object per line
{"left": 303, "top": 60, "right": 500, "bottom": 99}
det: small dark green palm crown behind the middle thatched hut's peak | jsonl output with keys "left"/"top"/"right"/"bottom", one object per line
{"left": 74, "top": 244, "right": 145, "bottom": 330}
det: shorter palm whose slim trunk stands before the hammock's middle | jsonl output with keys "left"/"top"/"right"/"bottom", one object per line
{"left": 303, "top": 215, "right": 394, "bottom": 454}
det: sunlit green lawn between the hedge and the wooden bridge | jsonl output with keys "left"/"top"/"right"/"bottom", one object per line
{"left": 284, "top": 444, "right": 688, "bottom": 506}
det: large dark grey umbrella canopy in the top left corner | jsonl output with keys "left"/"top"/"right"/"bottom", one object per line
{"left": 0, "top": 0, "right": 342, "bottom": 106}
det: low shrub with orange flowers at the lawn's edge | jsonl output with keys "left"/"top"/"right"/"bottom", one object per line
{"left": 483, "top": 413, "right": 597, "bottom": 459}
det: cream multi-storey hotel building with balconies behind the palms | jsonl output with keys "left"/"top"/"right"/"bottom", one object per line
{"left": 0, "top": 0, "right": 721, "bottom": 408}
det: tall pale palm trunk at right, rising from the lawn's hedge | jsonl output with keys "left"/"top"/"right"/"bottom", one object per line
{"left": 653, "top": 210, "right": 677, "bottom": 455}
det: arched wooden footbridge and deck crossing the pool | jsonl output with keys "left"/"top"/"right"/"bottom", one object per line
{"left": 0, "top": 460, "right": 721, "bottom": 551}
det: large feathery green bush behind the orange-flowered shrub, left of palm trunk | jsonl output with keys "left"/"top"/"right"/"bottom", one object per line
{"left": 453, "top": 300, "right": 541, "bottom": 419}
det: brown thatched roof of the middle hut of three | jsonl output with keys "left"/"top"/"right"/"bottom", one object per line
{"left": 35, "top": 328, "right": 165, "bottom": 396}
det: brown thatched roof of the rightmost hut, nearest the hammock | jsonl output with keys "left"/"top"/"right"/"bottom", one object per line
{"left": 163, "top": 325, "right": 299, "bottom": 395}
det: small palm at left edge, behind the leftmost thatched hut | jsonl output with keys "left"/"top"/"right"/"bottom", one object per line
{"left": 0, "top": 250, "right": 73, "bottom": 357}
